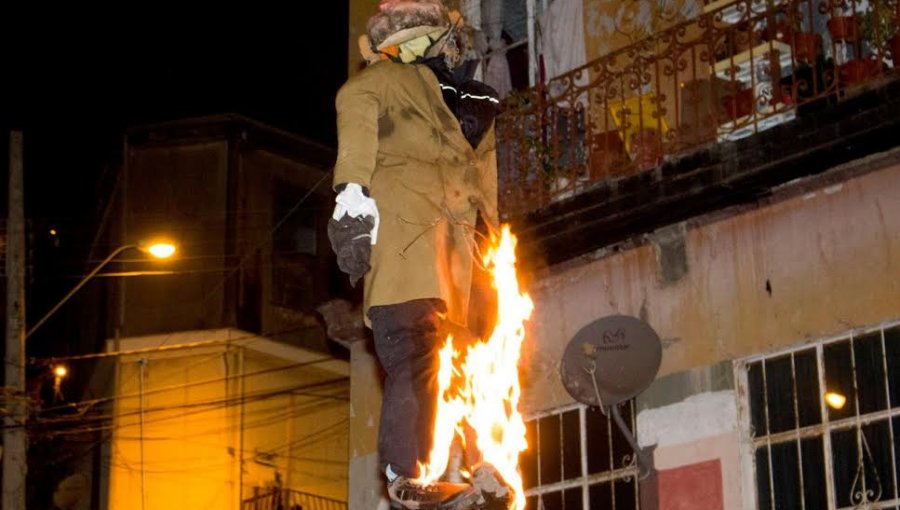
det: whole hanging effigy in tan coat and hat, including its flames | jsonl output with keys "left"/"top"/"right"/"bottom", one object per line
{"left": 328, "top": 0, "right": 531, "bottom": 504}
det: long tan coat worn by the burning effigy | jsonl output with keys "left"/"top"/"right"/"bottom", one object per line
{"left": 334, "top": 61, "right": 497, "bottom": 324}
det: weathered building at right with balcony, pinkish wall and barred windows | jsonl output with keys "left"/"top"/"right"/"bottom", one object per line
{"left": 350, "top": 0, "right": 900, "bottom": 510}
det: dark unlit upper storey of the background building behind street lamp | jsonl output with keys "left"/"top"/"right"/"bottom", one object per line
{"left": 110, "top": 116, "right": 339, "bottom": 350}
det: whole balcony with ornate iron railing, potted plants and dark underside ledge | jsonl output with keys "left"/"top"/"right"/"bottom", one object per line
{"left": 497, "top": 0, "right": 900, "bottom": 262}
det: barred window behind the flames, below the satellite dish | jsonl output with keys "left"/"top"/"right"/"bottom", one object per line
{"left": 521, "top": 402, "right": 639, "bottom": 510}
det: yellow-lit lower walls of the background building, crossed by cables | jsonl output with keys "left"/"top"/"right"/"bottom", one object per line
{"left": 105, "top": 329, "right": 348, "bottom": 509}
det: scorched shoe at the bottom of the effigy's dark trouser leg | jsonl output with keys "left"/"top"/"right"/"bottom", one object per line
{"left": 388, "top": 476, "right": 479, "bottom": 510}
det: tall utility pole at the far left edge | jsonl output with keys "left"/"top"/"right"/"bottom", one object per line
{"left": 2, "top": 131, "right": 28, "bottom": 510}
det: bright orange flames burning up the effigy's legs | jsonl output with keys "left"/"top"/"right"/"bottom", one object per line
{"left": 419, "top": 225, "right": 534, "bottom": 510}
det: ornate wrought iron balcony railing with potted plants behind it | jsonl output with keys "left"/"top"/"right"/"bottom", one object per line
{"left": 497, "top": 0, "right": 900, "bottom": 219}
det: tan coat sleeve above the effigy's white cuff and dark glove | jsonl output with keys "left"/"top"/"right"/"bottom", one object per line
{"left": 334, "top": 67, "right": 383, "bottom": 187}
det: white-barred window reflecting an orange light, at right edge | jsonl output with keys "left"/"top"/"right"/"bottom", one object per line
{"left": 737, "top": 324, "right": 900, "bottom": 510}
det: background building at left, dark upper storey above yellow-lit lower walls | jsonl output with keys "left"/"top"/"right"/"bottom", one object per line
{"left": 42, "top": 115, "right": 350, "bottom": 510}
